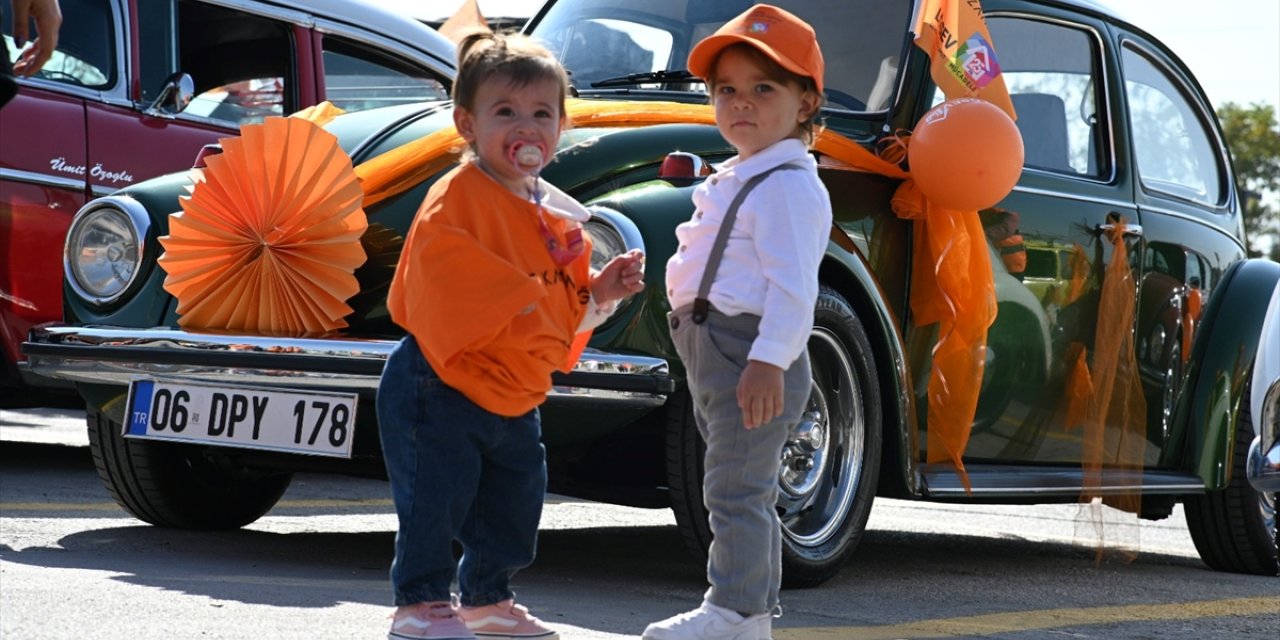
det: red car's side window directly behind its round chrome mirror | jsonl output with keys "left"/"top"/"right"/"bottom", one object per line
{"left": 138, "top": 0, "right": 300, "bottom": 125}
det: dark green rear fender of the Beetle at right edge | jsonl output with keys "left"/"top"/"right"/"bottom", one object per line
{"left": 1174, "top": 260, "right": 1280, "bottom": 492}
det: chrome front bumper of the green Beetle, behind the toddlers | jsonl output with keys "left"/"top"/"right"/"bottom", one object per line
{"left": 22, "top": 325, "right": 675, "bottom": 407}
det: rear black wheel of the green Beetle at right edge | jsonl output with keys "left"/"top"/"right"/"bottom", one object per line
{"left": 1183, "top": 394, "right": 1280, "bottom": 576}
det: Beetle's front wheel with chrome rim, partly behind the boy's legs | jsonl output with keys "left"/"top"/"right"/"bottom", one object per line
{"left": 667, "top": 287, "right": 883, "bottom": 589}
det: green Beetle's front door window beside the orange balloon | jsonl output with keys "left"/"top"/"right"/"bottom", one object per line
{"left": 987, "top": 17, "right": 1110, "bottom": 177}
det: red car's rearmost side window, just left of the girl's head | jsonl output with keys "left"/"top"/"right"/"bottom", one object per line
{"left": 324, "top": 36, "right": 449, "bottom": 111}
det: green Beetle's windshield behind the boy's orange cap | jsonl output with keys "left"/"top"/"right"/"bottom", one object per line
{"left": 531, "top": 0, "right": 913, "bottom": 111}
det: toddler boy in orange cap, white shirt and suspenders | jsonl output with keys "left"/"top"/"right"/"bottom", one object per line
{"left": 644, "top": 5, "right": 832, "bottom": 640}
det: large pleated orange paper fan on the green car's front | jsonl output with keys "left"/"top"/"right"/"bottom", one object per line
{"left": 159, "top": 118, "right": 369, "bottom": 335}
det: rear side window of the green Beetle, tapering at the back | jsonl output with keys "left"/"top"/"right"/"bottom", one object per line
{"left": 1121, "top": 47, "right": 1225, "bottom": 205}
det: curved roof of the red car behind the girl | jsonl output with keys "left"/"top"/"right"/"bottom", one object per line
{"left": 248, "top": 0, "right": 456, "bottom": 69}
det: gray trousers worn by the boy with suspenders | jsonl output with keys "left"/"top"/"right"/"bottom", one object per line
{"left": 668, "top": 306, "right": 810, "bottom": 614}
